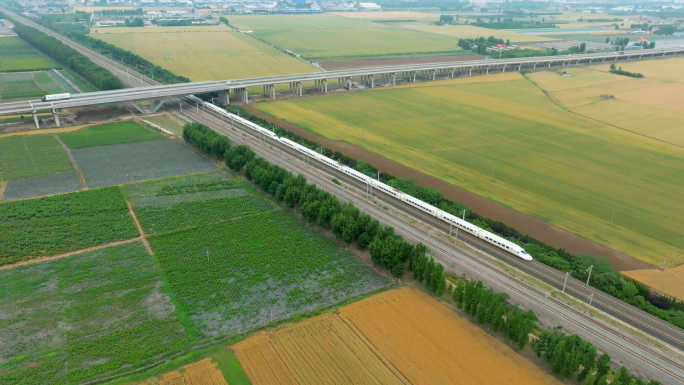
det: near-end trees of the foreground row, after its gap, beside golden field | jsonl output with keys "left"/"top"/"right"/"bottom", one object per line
{"left": 453, "top": 280, "right": 660, "bottom": 385}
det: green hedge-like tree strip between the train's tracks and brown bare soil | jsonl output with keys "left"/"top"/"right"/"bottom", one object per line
{"left": 226, "top": 105, "right": 684, "bottom": 327}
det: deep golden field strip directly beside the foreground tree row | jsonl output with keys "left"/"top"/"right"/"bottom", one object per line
{"left": 340, "top": 288, "right": 560, "bottom": 385}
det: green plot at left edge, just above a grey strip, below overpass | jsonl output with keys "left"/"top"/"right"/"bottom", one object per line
{"left": 0, "top": 134, "right": 73, "bottom": 181}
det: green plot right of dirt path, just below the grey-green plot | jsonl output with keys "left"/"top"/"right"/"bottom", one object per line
{"left": 126, "top": 173, "right": 274, "bottom": 234}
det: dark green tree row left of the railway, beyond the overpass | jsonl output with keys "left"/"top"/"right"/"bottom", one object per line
{"left": 0, "top": 12, "right": 124, "bottom": 90}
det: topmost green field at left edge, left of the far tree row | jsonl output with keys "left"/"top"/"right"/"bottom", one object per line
{"left": 0, "top": 36, "right": 61, "bottom": 72}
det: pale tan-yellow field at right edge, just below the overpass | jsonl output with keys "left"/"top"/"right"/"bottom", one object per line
{"left": 527, "top": 58, "right": 684, "bottom": 147}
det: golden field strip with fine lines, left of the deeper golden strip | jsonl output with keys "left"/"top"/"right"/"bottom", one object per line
{"left": 234, "top": 313, "right": 407, "bottom": 385}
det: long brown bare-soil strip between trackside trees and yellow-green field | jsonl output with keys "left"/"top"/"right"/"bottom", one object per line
{"left": 241, "top": 105, "right": 653, "bottom": 271}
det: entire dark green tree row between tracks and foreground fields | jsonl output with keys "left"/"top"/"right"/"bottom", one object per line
{"left": 184, "top": 119, "right": 659, "bottom": 385}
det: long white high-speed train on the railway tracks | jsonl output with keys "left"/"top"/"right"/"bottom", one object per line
{"left": 190, "top": 96, "right": 532, "bottom": 261}
